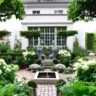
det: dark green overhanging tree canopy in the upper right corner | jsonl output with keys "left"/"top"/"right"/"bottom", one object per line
{"left": 68, "top": 0, "right": 96, "bottom": 22}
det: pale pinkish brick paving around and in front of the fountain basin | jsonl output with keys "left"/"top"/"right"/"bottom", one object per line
{"left": 16, "top": 69, "right": 74, "bottom": 96}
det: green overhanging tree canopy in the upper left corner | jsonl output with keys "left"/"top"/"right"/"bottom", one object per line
{"left": 0, "top": 0, "right": 25, "bottom": 21}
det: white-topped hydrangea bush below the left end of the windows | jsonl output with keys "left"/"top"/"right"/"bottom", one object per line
{"left": 22, "top": 51, "right": 36, "bottom": 64}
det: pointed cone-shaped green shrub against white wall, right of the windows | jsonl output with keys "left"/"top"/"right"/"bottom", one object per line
{"left": 72, "top": 38, "right": 87, "bottom": 58}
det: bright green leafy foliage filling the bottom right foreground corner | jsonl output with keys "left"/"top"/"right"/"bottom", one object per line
{"left": 60, "top": 81, "right": 96, "bottom": 96}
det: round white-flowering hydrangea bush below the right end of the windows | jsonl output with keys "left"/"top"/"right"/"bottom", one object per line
{"left": 58, "top": 49, "right": 71, "bottom": 64}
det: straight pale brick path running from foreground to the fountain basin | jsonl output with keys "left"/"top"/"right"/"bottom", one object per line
{"left": 36, "top": 84, "right": 57, "bottom": 96}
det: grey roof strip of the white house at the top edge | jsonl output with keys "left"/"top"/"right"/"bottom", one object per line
{"left": 23, "top": 0, "right": 71, "bottom": 3}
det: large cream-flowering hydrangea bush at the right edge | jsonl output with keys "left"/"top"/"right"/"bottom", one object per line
{"left": 73, "top": 59, "right": 96, "bottom": 82}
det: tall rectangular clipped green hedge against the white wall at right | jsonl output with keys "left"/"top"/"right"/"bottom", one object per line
{"left": 86, "top": 33, "right": 95, "bottom": 50}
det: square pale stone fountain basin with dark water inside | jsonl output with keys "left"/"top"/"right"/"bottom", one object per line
{"left": 34, "top": 71, "right": 60, "bottom": 84}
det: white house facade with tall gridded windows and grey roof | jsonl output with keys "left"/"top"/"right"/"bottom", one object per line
{"left": 21, "top": 0, "right": 74, "bottom": 49}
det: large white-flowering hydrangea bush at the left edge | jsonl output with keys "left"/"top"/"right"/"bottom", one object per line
{"left": 0, "top": 59, "right": 19, "bottom": 82}
